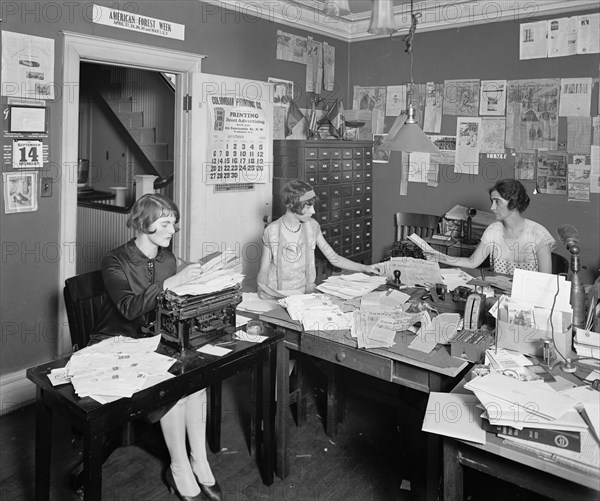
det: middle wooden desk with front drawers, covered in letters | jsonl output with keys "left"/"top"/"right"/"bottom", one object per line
{"left": 259, "top": 306, "right": 469, "bottom": 499}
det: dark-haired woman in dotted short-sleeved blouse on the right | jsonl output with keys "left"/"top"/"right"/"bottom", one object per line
{"left": 425, "top": 179, "right": 556, "bottom": 275}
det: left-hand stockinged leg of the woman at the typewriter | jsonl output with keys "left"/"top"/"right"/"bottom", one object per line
{"left": 160, "top": 397, "right": 200, "bottom": 497}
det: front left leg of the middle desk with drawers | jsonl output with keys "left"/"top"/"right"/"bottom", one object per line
{"left": 275, "top": 342, "right": 290, "bottom": 479}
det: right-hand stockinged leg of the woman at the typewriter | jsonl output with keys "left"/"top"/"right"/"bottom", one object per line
{"left": 185, "top": 390, "right": 215, "bottom": 485}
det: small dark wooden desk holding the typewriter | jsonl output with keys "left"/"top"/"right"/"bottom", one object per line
{"left": 27, "top": 332, "right": 283, "bottom": 501}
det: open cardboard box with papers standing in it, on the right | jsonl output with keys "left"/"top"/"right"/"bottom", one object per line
{"left": 496, "top": 307, "right": 573, "bottom": 360}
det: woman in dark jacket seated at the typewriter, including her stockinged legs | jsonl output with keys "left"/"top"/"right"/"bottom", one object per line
{"left": 90, "top": 194, "right": 221, "bottom": 501}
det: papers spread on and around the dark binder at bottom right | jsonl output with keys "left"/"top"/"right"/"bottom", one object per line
{"left": 423, "top": 371, "right": 600, "bottom": 475}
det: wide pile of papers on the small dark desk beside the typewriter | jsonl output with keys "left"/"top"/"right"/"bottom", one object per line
{"left": 53, "top": 336, "right": 176, "bottom": 403}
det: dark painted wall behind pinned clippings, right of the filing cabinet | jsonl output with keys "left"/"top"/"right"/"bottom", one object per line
{"left": 350, "top": 12, "right": 600, "bottom": 283}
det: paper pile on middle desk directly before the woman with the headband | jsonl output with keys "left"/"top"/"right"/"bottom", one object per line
{"left": 279, "top": 294, "right": 352, "bottom": 331}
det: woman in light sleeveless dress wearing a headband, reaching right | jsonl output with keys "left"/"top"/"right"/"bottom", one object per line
{"left": 257, "top": 179, "right": 383, "bottom": 298}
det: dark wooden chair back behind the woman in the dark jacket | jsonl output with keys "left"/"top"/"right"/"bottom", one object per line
{"left": 63, "top": 270, "right": 108, "bottom": 351}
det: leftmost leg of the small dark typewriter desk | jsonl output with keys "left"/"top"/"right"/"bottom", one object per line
{"left": 35, "top": 387, "right": 52, "bottom": 501}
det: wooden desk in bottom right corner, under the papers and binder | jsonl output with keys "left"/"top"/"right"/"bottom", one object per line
{"left": 443, "top": 433, "right": 600, "bottom": 501}
